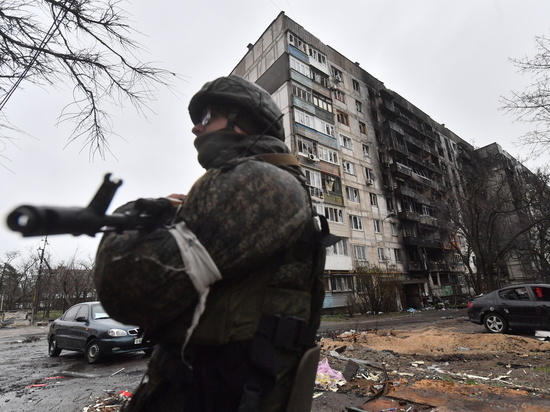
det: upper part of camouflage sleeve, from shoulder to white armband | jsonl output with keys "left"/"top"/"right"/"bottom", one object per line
{"left": 181, "top": 161, "right": 311, "bottom": 277}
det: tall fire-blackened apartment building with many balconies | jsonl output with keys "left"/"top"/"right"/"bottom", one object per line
{"left": 232, "top": 12, "right": 536, "bottom": 311}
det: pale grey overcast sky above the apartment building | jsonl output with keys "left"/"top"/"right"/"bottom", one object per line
{"left": 0, "top": 0, "right": 550, "bottom": 262}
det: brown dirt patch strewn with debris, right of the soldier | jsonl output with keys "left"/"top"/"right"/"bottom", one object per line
{"left": 312, "top": 320, "right": 550, "bottom": 412}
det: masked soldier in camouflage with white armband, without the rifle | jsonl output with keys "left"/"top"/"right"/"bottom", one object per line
{"left": 95, "top": 76, "right": 335, "bottom": 412}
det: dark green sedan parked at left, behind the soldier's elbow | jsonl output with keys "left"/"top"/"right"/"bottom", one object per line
{"left": 48, "top": 302, "right": 154, "bottom": 363}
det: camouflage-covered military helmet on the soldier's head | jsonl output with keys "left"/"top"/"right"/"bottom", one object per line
{"left": 189, "top": 75, "right": 285, "bottom": 141}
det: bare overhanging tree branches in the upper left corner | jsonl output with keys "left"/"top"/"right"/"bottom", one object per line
{"left": 0, "top": 0, "right": 174, "bottom": 157}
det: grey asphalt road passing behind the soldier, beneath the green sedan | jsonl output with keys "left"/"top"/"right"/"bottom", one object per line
{"left": 0, "top": 310, "right": 470, "bottom": 412}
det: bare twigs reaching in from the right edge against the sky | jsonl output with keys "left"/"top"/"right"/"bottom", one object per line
{"left": 501, "top": 36, "right": 550, "bottom": 157}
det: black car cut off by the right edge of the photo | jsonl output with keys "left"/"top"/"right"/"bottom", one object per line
{"left": 468, "top": 284, "right": 550, "bottom": 333}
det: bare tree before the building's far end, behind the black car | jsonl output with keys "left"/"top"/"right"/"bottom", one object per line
{"left": 449, "top": 151, "right": 550, "bottom": 293}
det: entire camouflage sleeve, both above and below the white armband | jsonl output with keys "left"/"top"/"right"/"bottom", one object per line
{"left": 94, "top": 161, "right": 311, "bottom": 340}
